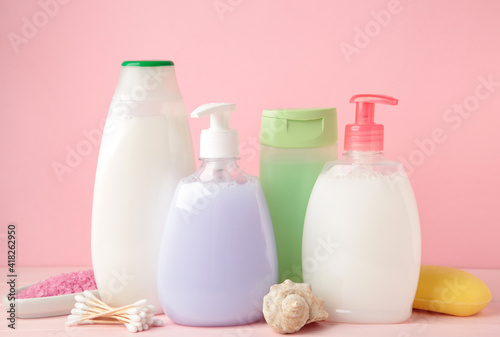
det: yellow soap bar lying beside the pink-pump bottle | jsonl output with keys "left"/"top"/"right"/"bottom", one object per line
{"left": 413, "top": 266, "right": 491, "bottom": 316}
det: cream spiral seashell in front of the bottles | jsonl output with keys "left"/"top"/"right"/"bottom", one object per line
{"left": 262, "top": 280, "right": 328, "bottom": 333}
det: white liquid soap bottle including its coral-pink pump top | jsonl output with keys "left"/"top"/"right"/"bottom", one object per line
{"left": 302, "top": 95, "right": 421, "bottom": 323}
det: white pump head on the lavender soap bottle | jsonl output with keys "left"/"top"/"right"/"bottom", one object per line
{"left": 191, "top": 103, "right": 239, "bottom": 158}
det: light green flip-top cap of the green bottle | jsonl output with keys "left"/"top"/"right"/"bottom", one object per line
{"left": 260, "top": 108, "right": 338, "bottom": 148}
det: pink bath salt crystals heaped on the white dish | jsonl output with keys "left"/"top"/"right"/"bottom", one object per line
{"left": 17, "top": 269, "right": 97, "bottom": 299}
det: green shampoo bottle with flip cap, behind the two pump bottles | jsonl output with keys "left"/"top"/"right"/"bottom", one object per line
{"left": 260, "top": 108, "right": 337, "bottom": 283}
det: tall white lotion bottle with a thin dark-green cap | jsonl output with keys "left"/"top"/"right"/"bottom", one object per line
{"left": 91, "top": 61, "right": 195, "bottom": 312}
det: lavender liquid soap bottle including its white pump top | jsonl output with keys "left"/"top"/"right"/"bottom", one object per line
{"left": 158, "top": 103, "right": 278, "bottom": 326}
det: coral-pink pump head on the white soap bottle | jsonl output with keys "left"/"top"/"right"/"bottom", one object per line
{"left": 344, "top": 94, "right": 398, "bottom": 151}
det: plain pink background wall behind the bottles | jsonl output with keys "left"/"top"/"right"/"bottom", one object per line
{"left": 0, "top": 0, "right": 500, "bottom": 268}
